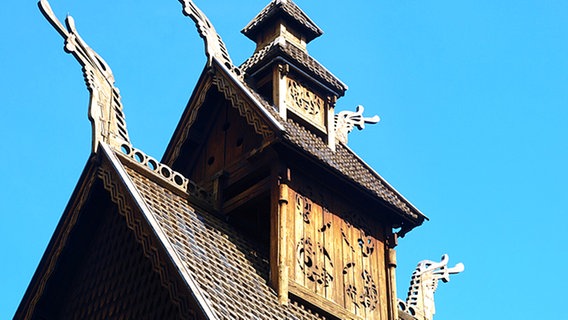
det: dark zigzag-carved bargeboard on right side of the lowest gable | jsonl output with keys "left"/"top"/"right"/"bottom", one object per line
{"left": 98, "top": 167, "right": 195, "bottom": 319}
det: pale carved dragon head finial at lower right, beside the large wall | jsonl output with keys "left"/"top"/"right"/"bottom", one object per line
{"left": 399, "top": 254, "right": 464, "bottom": 320}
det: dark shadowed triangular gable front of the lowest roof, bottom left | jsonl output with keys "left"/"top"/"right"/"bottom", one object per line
{"left": 15, "top": 143, "right": 207, "bottom": 319}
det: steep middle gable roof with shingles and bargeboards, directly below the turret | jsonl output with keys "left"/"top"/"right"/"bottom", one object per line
{"left": 162, "top": 60, "right": 427, "bottom": 228}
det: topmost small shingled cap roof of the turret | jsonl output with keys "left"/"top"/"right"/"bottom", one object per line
{"left": 241, "top": 0, "right": 323, "bottom": 42}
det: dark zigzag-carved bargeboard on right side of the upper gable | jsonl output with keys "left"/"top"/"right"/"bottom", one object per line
{"left": 213, "top": 75, "right": 274, "bottom": 138}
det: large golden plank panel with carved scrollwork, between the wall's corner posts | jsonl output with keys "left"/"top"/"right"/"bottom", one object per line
{"left": 287, "top": 180, "right": 387, "bottom": 319}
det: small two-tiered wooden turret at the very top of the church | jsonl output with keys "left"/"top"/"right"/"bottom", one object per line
{"left": 241, "top": 0, "right": 347, "bottom": 149}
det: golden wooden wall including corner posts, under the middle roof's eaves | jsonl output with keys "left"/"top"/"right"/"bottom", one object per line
{"left": 271, "top": 171, "right": 392, "bottom": 320}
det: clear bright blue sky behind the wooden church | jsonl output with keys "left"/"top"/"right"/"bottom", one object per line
{"left": 0, "top": 0, "right": 568, "bottom": 320}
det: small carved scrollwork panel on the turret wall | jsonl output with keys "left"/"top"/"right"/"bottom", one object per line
{"left": 286, "top": 78, "right": 326, "bottom": 130}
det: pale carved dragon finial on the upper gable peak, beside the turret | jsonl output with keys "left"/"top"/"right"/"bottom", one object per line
{"left": 179, "top": 0, "right": 240, "bottom": 75}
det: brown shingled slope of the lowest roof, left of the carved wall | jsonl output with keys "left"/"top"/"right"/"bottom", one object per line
{"left": 115, "top": 146, "right": 324, "bottom": 319}
